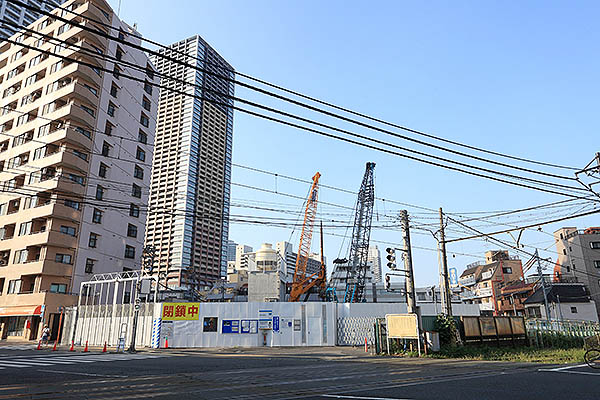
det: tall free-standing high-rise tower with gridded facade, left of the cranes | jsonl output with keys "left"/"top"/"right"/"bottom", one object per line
{"left": 146, "top": 36, "right": 234, "bottom": 290}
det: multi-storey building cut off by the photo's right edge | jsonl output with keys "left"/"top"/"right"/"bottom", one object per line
{"left": 554, "top": 227, "right": 600, "bottom": 315}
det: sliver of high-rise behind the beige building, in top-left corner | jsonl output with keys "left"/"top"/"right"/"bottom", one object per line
{"left": 0, "top": 0, "right": 64, "bottom": 40}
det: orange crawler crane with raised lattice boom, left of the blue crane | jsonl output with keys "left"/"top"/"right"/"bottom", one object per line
{"left": 289, "top": 172, "right": 326, "bottom": 301}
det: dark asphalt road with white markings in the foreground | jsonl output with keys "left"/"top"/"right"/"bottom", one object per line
{"left": 0, "top": 345, "right": 600, "bottom": 400}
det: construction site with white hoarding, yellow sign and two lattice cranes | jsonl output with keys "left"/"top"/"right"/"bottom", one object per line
{"left": 61, "top": 162, "right": 479, "bottom": 350}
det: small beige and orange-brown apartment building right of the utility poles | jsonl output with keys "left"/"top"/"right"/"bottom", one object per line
{"left": 458, "top": 250, "right": 524, "bottom": 316}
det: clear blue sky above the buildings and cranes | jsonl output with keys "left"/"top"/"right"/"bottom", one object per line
{"left": 110, "top": 0, "right": 600, "bottom": 285}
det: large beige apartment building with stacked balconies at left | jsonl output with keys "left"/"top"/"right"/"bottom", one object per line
{"left": 0, "top": 0, "right": 158, "bottom": 339}
